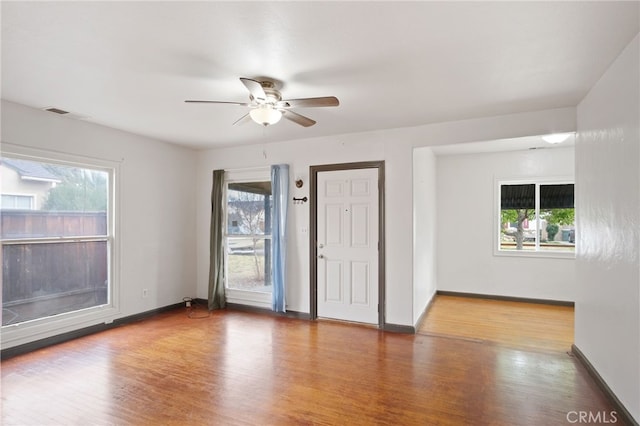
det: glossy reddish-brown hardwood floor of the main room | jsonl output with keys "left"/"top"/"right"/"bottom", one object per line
{"left": 1, "top": 304, "right": 612, "bottom": 426}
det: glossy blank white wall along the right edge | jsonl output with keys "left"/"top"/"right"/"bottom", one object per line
{"left": 575, "top": 36, "right": 640, "bottom": 421}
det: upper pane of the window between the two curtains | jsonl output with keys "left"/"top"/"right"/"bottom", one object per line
{"left": 227, "top": 181, "right": 271, "bottom": 235}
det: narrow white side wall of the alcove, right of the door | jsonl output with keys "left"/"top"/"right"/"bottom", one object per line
{"left": 413, "top": 148, "right": 437, "bottom": 325}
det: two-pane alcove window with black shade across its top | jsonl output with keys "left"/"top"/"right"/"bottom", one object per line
{"left": 497, "top": 181, "right": 575, "bottom": 256}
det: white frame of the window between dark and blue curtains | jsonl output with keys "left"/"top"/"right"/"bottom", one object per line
{"left": 222, "top": 166, "right": 272, "bottom": 309}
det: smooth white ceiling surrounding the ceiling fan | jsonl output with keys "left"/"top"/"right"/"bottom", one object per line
{"left": 1, "top": 1, "right": 640, "bottom": 148}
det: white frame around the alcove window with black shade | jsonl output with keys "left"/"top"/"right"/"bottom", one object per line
{"left": 493, "top": 176, "right": 576, "bottom": 259}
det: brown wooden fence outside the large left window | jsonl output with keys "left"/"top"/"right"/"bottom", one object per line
{"left": 0, "top": 211, "right": 108, "bottom": 323}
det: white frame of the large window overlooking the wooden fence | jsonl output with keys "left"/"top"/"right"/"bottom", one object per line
{"left": 1, "top": 143, "right": 120, "bottom": 349}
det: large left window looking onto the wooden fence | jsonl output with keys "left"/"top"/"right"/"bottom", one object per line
{"left": 0, "top": 149, "right": 115, "bottom": 340}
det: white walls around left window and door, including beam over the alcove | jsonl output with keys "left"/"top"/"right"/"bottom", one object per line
{"left": 2, "top": 101, "right": 575, "bottom": 332}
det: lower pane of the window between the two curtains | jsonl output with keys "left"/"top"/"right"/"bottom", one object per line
{"left": 226, "top": 238, "right": 272, "bottom": 293}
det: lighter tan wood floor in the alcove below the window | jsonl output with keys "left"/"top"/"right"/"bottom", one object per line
{"left": 418, "top": 295, "right": 574, "bottom": 352}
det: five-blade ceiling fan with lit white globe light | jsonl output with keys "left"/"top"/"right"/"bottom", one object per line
{"left": 185, "top": 77, "right": 340, "bottom": 127}
